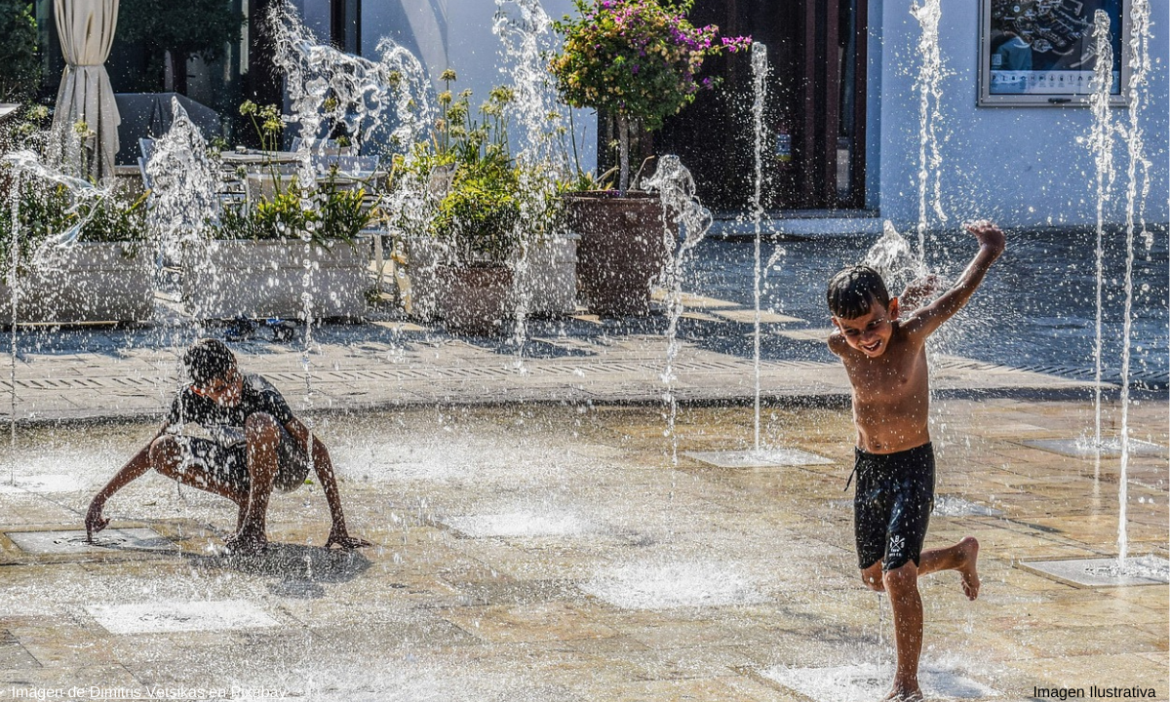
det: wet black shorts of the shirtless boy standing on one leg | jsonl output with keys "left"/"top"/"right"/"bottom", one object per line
{"left": 853, "top": 443, "right": 935, "bottom": 571}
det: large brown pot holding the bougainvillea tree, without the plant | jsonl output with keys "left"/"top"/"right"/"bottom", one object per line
{"left": 565, "top": 193, "right": 676, "bottom": 316}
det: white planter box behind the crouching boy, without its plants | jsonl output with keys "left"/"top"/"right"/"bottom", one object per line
{"left": 183, "top": 239, "right": 372, "bottom": 319}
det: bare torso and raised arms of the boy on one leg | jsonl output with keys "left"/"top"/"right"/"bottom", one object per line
{"left": 828, "top": 222, "right": 1005, "bottom": 454}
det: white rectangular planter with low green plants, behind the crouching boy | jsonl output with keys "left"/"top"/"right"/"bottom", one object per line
{"left": 183, "top": 171, "right": 373, "bottom": 319}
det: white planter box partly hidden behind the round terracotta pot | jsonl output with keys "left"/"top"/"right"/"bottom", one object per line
{"left": 407, "top": 234, "right": 580, "bottom": 319}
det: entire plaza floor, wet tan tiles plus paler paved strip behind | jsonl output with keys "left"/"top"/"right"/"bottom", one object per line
{"left": 0, "top": 286, "right": 1170, "bottom": 702}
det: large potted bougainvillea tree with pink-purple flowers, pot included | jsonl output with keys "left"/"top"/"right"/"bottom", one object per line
{"left": 549, "top": 0, "right": 751, "bottom": 315}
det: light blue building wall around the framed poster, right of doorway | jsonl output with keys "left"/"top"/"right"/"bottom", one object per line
{"left": 869, "top": 0, "right": 1170, "bottom": 227}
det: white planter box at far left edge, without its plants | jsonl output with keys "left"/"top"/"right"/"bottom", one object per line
{"left": 0, "top": 242, "right": 154, "bottom": 324}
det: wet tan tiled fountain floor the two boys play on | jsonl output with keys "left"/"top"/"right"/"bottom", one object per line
{"left": 0, "top": 398, "right": 1170, "bottom": 702}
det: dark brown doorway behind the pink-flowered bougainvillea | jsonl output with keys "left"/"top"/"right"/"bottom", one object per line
{"left": 654, "top": 0, "right": 868, "bottom": 212}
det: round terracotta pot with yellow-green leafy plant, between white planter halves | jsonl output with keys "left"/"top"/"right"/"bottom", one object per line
{"left": 394, "top": 78, "right": 574, "bottom": 333}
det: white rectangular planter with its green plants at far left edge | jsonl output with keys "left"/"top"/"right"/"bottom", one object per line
{"left": 0, "top": 180, "right": 154, "bottom": 324}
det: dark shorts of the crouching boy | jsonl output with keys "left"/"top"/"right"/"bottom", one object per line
{"left": 171, "top": 427, "right": 311, "bottom": 493}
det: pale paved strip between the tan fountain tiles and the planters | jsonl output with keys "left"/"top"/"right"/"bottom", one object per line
{"left": 0, "top": 287, "right": 1093, "bottom": 421}
